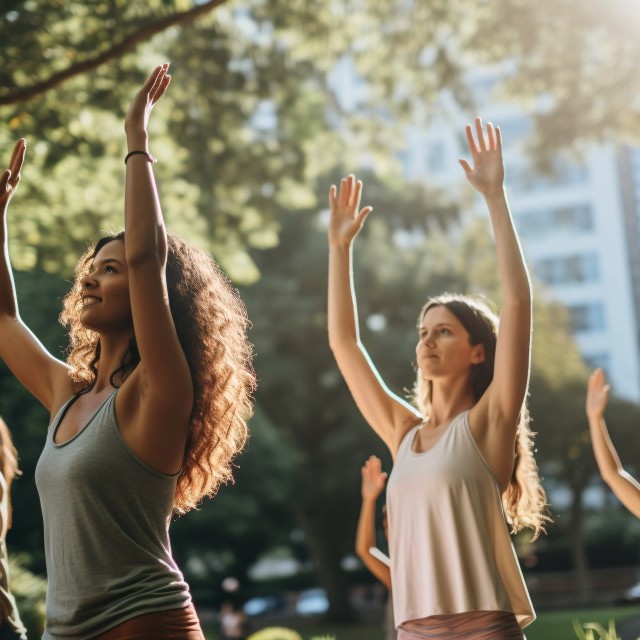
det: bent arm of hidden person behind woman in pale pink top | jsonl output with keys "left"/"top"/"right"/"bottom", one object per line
{"left": 356, "top": 456, "right": 391, "bottom": 590}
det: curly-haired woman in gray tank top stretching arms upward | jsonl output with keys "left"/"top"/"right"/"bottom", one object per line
{"left": 0, "top": 65, "right": 253, "bottom": 640}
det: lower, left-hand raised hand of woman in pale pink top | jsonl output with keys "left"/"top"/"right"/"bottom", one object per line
{"left": 329, "top": 174, "right": 373, "bottom": 245}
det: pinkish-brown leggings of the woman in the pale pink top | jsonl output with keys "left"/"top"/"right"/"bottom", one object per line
{"left": 398, "top": 611, "right": 525, "bottom": 640}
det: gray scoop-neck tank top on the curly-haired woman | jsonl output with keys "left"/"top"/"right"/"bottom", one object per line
{"left": 36, "top": 392, "right": 191, "bottom": 640}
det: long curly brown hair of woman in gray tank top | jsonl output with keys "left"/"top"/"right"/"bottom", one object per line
{"left": 60, "top": 231, "right": 255, "bottom": 514}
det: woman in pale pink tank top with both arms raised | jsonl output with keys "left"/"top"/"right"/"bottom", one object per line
{"left": 329, "top": 118, "right": 547, "bottom": 640}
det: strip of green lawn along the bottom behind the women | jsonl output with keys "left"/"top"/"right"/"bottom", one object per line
{"left": 204, "top": 607, "right": 640, "bottom": 640}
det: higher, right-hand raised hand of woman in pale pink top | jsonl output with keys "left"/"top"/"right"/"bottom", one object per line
{"left": 459, "top": 118, "right": 504, "bottom": 196}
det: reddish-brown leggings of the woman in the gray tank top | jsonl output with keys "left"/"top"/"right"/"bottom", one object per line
{"left": 92, "top": 605, "right": 205, "bottom": 640}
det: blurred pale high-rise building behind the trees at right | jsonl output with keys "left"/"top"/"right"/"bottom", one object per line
{"left": 402, "top": 76, "right": 640, "bottom": 400}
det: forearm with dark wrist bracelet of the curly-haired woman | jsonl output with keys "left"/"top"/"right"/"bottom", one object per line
{"left": 124, "top": 131, "right": 167, "bottom": 266}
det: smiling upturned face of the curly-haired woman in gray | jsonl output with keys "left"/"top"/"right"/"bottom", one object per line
{"left": 80, "top": 240, "right": 133, "bottom": 333}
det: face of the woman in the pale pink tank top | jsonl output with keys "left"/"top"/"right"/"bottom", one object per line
{"left": 416, "top": 305, "right": 484, "bottom": 380}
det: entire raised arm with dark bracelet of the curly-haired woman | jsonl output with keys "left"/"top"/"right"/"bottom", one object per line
{"left": 125, "top": 65, "right": 193, "bottom": 464}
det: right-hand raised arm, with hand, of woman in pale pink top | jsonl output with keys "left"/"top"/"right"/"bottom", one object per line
{"left": 460, "top": 118, "right": 531, "bottom": 479}
